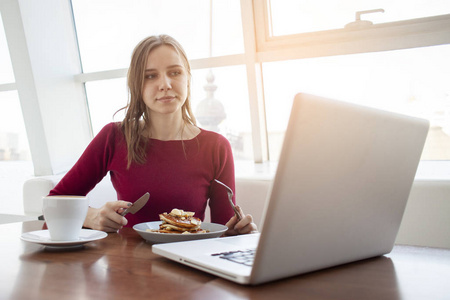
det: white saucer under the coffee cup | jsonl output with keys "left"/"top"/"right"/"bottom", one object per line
{"left": 20, "top": 229, "right": 108, "bottom": 247}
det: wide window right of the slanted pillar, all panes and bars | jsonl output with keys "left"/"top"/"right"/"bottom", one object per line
{"left": 72, "top": 0, "right": 450, "bottom": 165}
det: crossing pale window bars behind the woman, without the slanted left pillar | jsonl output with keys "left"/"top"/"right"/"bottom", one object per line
{"left": 75, "top": 0, "right": 450, "bottom": 163}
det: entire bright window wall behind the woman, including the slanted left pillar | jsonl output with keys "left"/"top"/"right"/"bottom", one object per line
{"left": 0, "top": 0, "right": 450, "bottom": 213}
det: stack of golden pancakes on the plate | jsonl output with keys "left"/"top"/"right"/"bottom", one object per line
{"left": 147, "top": 208, "right": 208, "bottom": 234}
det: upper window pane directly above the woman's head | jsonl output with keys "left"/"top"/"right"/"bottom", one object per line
{"left": 72, "top": 0, "right": 244, "bottom": 72}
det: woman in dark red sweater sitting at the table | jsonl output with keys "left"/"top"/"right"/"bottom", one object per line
{"left": 50, "top": 35, "right": 256, "bottom": 235}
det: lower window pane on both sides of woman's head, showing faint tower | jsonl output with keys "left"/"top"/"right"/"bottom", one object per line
{"left": 86, "top": 66, "right": 253, "bottom": 160}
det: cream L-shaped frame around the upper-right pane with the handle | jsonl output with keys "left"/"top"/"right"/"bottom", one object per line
{"left": 253, "top": 0, "right": 450, "bottom": 58}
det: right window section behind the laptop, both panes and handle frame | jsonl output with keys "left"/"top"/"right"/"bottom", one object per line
{"left": 254, "top": 0, "right": 450, "bottom": 161}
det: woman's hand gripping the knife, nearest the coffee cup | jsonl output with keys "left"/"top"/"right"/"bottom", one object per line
{"left": 83, "top": 200, "right": 132, "bottom": 232}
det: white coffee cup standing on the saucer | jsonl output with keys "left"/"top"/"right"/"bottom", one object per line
{"left": 42, "top": 196, "right": 89, "bottom": 241}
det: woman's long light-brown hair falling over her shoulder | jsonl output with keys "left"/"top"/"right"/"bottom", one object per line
{"left": 120, "top": 35, "right": 197, "bottom": 168}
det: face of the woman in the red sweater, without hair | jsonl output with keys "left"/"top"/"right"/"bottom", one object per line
{"left": 143, "top": 45, "right": 188, "bottom": 117}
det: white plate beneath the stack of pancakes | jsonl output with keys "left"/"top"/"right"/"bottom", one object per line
{"left": 133, "top": 221, "right": 228, "bottom": 243}
